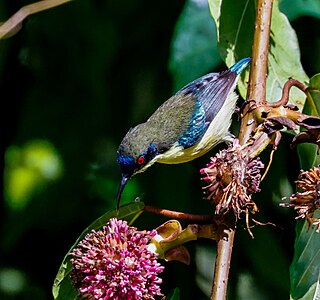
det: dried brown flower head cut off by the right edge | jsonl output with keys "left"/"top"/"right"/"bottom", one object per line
{"left": 281, "top": 165, "right": 320, "bottom": 232}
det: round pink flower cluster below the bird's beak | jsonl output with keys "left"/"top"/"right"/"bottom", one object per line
{"left": 71, "top": 219, "right": 164, "bottom": 300}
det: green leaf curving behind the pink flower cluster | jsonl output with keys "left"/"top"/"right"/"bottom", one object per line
{"left": 52, "top": 202, "right": 144, "bottom": 300}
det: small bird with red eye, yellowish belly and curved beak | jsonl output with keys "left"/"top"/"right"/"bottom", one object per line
{"left": 116, "top": 57, "right": 251, "bottom": 211}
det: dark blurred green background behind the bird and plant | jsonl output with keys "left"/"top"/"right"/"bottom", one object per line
{"left": 0, "top": 0, "right": 320, "bottom": 299}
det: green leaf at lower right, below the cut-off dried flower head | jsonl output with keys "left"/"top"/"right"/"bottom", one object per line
{"left": 290, "top": 211, "right": 320, "bottom": 300}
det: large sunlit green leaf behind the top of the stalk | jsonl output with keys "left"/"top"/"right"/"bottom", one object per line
{"left": 209, "top": 0, "right": 308, "bottom": 109}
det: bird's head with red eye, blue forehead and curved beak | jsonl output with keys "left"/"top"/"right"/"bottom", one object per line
{"left": 117, "top": 123, "right": 158, "bottom": 209}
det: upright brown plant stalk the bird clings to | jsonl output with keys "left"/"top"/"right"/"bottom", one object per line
{"left": 211, "top": 0, "right": 273, "bottom": 300}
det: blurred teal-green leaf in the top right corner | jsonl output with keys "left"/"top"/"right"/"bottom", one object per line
{"left": 280, "top": 0, "right": 320, "bottom": 20}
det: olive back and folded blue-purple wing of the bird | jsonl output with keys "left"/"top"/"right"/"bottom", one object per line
{"left": 145, "top": 70, "right": 237, "bottom": 153}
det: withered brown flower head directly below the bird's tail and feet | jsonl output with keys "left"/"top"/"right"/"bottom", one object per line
{"left": 200, "top": 139, "right": 264, "bottom": 218}
